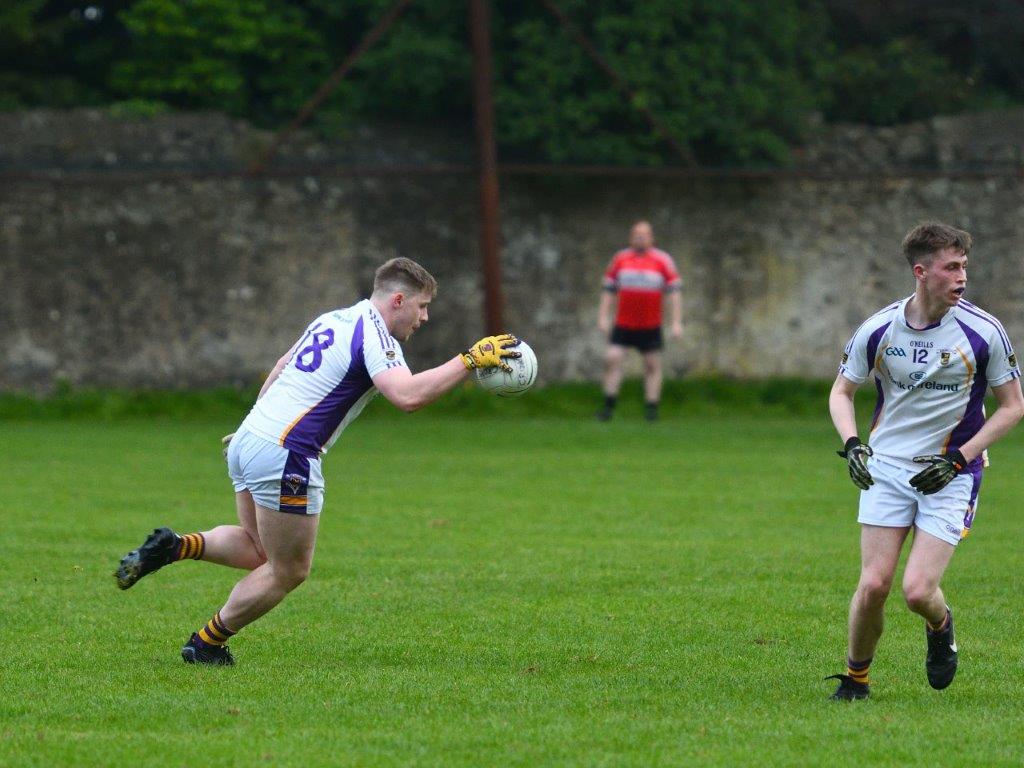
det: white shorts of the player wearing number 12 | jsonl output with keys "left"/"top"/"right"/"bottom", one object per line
{"left": 857, "top": 456, "right": 981, "bottom": 546}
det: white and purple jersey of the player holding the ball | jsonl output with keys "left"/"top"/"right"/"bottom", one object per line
{"left": 242, "top": 299, "right": 406, "bottom": 458}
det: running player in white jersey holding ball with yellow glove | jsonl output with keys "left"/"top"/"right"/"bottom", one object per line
{"left": 115, "top": 258, "right": 519, "bottom": 665}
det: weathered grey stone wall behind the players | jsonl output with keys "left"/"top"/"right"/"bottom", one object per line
{"left": 0, "top": 112, "right": 1024, "bottom": 391}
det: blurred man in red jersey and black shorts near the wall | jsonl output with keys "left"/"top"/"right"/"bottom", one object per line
{"left": 597, "top": 221, "right": 683, "bottom": 421}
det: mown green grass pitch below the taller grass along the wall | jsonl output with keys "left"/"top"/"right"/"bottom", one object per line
{"left": 0, "top": 395, "right": 1024, "bottom": 766}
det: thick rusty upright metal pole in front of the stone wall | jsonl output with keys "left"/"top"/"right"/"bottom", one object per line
{"left": 469, "top": 0, "right": 505, "bottom": 334}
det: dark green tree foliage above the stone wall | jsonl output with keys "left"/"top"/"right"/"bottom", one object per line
{"left": 0, "top": 0, "right": 1024, "bottom": 165}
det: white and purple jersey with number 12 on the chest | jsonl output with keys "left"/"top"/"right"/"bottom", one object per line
{"left": 839, "top": 296, "right": 1020, "bottom": 471}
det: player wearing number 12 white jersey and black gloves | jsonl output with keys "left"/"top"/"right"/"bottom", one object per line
{"left": 828, "top": 222, "right": 1024, "bottom": 700}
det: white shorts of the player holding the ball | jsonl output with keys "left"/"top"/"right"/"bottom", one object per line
{"left": 227, "top": 429, "right": 324, "bottom": 515}
